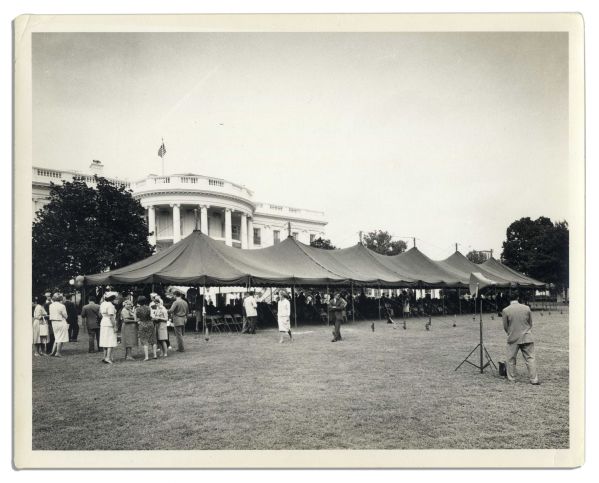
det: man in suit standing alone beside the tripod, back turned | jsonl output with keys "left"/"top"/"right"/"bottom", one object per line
{"left": 502, "top": 299, "right": 540, "bottom": 385}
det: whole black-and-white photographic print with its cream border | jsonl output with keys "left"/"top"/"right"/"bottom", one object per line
{"left": 14, "top": 14, "right": 584, "bottom": 467}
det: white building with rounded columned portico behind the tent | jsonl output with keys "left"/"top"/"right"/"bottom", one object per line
{"left": 32, "top": 161, "right": 327, "bottom": 250}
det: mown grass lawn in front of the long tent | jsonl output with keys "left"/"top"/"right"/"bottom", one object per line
{"left": 33, "top": 312, "right": 568, "bottom": 450}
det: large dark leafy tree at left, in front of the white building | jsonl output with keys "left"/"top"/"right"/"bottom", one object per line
{"left": 32, "top": 177, "right": 153, "bottom": 294}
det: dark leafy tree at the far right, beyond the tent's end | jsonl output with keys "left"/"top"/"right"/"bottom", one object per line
{"left": 501, "top": 216, "right": 570, "bottom": 288}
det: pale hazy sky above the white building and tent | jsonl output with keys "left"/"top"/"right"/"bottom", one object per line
{"left": 33, "top": 32, "right": 569, "bottom": 259}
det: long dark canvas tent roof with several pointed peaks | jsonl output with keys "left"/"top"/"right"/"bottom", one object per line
{"left": 85, "top": 231, "right": 545, "bottom": 288}
